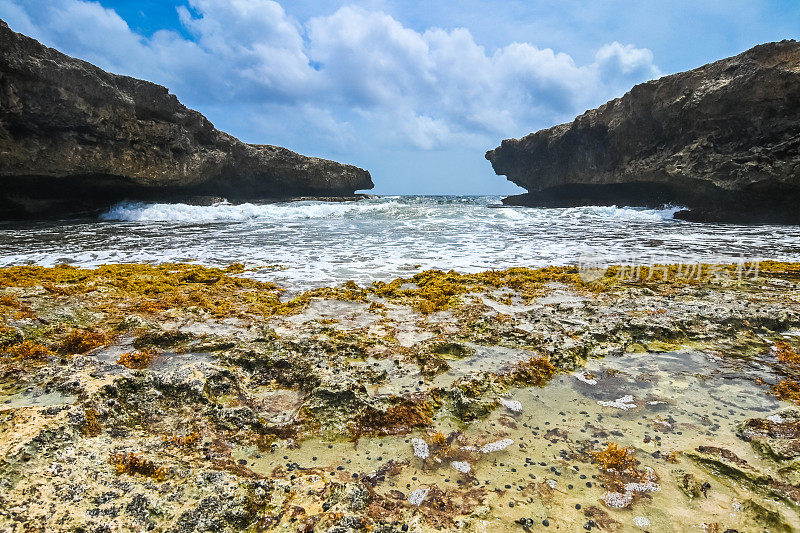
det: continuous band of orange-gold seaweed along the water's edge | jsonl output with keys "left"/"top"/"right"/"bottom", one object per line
{"left": 6, "top": 261, "right": 800, "bottom": 324}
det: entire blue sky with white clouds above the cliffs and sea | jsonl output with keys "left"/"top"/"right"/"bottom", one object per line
{"left": 0, "top": 0, "right": 800, "bottom": 195}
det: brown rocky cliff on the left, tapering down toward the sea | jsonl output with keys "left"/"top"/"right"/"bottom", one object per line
{"left": 0, "top": 20, "right": 373, "bottom": 218}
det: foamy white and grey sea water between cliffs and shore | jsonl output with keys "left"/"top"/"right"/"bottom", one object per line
{"left": 0, "top": 196, "right": 800, "bottom": 291}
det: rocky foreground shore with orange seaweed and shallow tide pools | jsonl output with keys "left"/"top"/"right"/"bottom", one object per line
{"left": 0, "top": 262, "right": 800, "bottom": 532}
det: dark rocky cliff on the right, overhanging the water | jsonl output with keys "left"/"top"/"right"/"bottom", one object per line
{"left": 486, "top": 41, "right": 800, "bottom": 223}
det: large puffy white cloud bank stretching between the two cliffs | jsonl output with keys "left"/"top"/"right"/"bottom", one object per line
{"left": 0, "top": 0, "right": 660, "bottom": 150}
